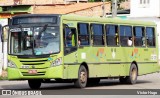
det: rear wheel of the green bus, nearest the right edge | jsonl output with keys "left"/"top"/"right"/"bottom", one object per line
{"left": 126, "top": 63, "right": 138, "bottom": 84}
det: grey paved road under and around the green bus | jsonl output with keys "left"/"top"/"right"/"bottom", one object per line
{"left": 0, "top": 73, "right": 160, "bottom": 90}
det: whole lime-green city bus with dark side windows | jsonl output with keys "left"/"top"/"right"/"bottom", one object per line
{"left": 1, "top": 14, "right": 160, "bottom": 89}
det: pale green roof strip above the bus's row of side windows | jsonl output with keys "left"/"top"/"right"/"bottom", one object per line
{"left": 62, "top": 14, "right": 156, "bottom": 26}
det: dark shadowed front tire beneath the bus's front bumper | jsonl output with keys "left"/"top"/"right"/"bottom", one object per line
{"left": 28, "top": 79, "right": 41, "bottom": 89}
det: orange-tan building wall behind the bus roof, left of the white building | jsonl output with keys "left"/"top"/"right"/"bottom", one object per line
{"left": 32, "top": 2, "right": 110, "bottom": 16}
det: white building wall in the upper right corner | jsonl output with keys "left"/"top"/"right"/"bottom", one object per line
{"left": 130, "top": 0, "right": 160, "bottom": 17}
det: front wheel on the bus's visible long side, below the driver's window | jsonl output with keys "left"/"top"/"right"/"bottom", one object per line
{"left": 74, "top": 65, "right": 88, "bottom": 88}
